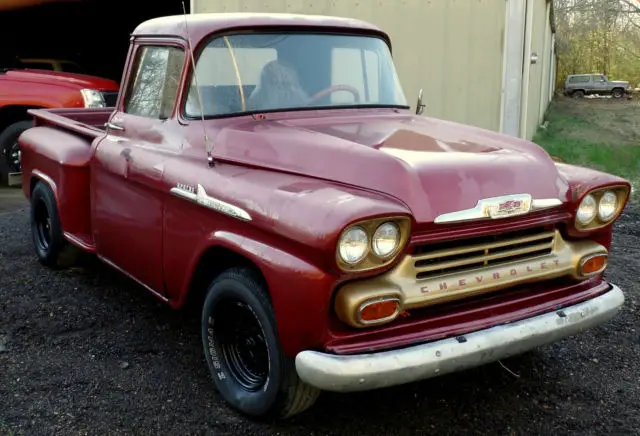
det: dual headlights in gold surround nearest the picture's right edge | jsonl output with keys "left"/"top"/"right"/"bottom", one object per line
{"left": 576, "top": 186, "right": 629, "bottom": 230}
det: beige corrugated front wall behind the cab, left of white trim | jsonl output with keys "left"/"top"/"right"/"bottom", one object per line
{"left": 192, "top": 0, "right": 508, "bottom": 130}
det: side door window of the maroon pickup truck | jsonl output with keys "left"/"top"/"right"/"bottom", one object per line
{"left": 124, "top": 45, "right": 185, "bottom": 119}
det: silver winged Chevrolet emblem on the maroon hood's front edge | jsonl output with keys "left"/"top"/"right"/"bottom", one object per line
{"left": 434, "top": 194, "right": 562, "bottom": 224}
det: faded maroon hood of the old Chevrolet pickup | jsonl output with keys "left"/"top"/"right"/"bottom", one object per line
{"left": 212, "top": 112, "right": 568, "bottom": 223}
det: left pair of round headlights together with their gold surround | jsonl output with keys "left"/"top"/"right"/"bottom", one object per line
{"left": 336, "top": 217, "right": 411, "bottom": 271}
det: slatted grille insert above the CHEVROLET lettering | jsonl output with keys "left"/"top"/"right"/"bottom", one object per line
{"left": 413, "top": 227, "right": 555, "bottom": 279}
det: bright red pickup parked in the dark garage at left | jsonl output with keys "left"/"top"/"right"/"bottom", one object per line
{"left": 0, "top": 57, "right": 118, "bottom": 185}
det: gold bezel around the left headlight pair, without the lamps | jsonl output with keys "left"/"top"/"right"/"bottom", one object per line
{"left": 336, "top": 216, "right": 411, "bottom": 272}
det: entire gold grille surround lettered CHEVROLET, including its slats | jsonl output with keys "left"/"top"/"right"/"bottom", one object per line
{"left": 334, "top": 228, "right": 608, "bottom": 328}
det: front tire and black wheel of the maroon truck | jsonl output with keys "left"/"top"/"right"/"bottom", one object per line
{"left": 201, "top": 268, "right": 320, "bottom": 419}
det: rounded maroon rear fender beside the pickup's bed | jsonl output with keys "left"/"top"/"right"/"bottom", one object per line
{"left": 18, "top": 127, "right": 93, "bottom": 239}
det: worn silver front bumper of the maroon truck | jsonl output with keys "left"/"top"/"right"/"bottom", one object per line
{"left": 296, "top": 284, "right": 624, "bottom": 392}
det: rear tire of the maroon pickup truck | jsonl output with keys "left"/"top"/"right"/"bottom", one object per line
{"left": 30, "top": 182, "right": 79, "bottom": 268}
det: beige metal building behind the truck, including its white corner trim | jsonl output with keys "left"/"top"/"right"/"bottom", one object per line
{"left": 191, "top": 0, "right": 556, "bottom": 139}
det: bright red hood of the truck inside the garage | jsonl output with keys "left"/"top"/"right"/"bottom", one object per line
{"left": 4, "top": 69, "right": 118, "bottom": 91}
